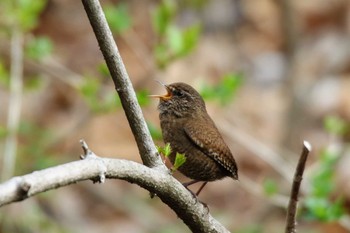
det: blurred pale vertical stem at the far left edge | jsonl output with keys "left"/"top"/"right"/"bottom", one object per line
{"left": 1, "top": 26, "right": 23, "bottom": 180}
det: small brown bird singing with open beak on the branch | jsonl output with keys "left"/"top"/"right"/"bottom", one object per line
{"left": 152, "top": 82, "right": 238, "bottom": 195}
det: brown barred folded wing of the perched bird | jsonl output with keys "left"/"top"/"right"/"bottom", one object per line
{"left": 184, "top": 120, "right": 238, "bottom": 179}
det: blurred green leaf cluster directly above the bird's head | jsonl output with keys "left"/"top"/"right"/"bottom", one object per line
{"left": 152, "top": 0, "right": 201, "bottom": 69}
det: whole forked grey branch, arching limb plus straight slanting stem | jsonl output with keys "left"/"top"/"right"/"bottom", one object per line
{"left": 0, "top": 0, "right": 232, "bottom": 233}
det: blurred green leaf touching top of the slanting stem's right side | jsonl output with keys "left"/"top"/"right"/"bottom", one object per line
{"left": 103, "top": 3, "right": 132, "bottom": 34}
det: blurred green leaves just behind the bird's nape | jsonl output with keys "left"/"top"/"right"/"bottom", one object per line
{"left": 200, "top": 73, "right": 243, "bottom": 105}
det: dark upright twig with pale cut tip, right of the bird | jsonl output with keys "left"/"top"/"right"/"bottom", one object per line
{"left": 285, "top": 141, "right": 311, "bottom": 233}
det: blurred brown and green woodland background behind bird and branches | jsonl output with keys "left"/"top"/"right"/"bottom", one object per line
{"left": 0, "top": 0, "right": 350, "bottom": 233}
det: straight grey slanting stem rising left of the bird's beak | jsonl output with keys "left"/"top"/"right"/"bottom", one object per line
{"left": 82, "top": 0, "right": 167, "bottom": 169}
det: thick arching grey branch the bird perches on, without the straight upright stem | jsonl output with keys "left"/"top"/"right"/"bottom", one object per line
{"left": 0, "top": 142, "right": 228, "bottom": 233}
